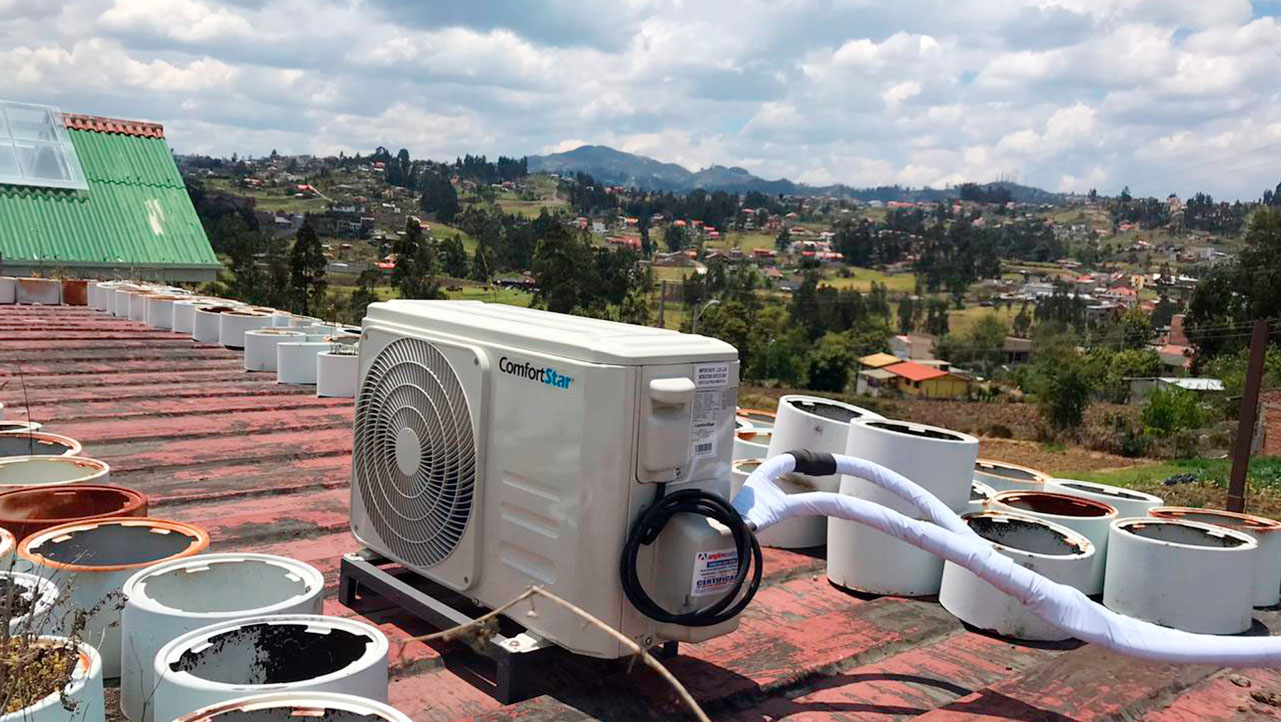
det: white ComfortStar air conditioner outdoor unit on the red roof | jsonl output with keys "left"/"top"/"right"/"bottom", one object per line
{"left": 351, "top": 301, "right": 758, "bottom": 658}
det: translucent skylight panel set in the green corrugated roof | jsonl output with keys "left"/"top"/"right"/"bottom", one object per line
{"left": 0, "top": 100, "right": 88, "bottom": 191}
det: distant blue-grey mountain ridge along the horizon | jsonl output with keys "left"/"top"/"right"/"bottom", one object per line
{"left": 528, "top": 145, "right": 1063, "bottom": 202}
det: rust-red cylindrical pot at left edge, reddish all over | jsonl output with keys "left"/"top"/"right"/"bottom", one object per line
{"left": 0, "top": 484, "right": 147, "bottom": 539}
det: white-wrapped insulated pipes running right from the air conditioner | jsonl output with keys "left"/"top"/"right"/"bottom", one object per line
{"left": 733, "top": 451, "right": 1281, "bottom": 667}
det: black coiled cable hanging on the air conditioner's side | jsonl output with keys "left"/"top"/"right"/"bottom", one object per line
{"left": 620, "top": 484, "right": 761, "bottom": 627}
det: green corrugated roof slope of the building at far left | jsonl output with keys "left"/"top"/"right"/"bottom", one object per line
{"left": 0, "top": 129, "right": 218, "bottom": 268}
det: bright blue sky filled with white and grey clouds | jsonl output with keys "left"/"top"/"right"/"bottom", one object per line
{"left": 0, "top": 0, "right": 1281, "bottom": 198}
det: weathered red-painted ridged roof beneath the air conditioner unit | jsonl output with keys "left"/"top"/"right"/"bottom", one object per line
{"left": 0, "top": 306, "right": 1281, "bottom": 722}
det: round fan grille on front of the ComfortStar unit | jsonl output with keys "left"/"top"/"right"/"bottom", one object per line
{"left": 352, "top": 338, "right": 475, "bottom": 567}
